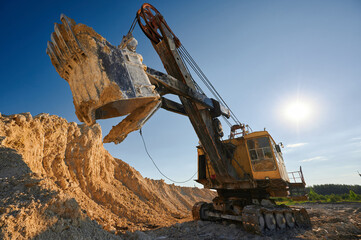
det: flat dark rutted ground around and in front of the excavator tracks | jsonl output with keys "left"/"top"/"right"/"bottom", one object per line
{"left": 124, "top": 203, "right": 361, "bottom": 240}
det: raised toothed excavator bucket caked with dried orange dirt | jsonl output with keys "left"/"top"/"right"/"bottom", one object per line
{"left": 46, "top": 14, "right": 161, "bottom": 143}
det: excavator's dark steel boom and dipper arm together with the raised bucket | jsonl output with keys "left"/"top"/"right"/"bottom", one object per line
{"left": 47, "top": 12, "right": 237, "bottom": 184}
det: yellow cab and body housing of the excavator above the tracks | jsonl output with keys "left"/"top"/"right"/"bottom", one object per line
{"left": 198, "top": 131, "right": 290, "bottom": 197}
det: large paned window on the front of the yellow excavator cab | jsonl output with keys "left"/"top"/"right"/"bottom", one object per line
{"left": 247, "top": 137, "right": 276, "bottom": 171}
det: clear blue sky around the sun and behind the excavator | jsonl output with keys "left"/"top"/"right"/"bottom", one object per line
{"left": 0, "top": 0, "right": 361, "bottom": 186}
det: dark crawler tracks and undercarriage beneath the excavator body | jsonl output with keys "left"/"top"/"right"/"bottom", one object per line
{"left": 192, "top": 197, "right": 311, "bottom": 235}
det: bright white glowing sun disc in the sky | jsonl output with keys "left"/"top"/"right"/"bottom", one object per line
{"left": 285, "top": 100, "right": 311, "bottom": 123}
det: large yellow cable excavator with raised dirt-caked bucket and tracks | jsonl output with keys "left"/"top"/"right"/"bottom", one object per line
{"left": 46, "top": 3, "right": 311, "bottom": 234}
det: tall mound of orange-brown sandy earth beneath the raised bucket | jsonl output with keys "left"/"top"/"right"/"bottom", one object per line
{"left": 0, "top": 113, "right": 214, "bottom": 239}
